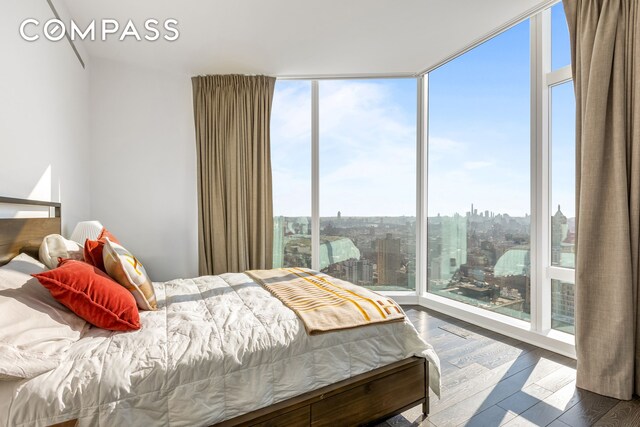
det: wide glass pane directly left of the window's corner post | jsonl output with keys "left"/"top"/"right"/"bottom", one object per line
{"left": 319, "top": 79, "right": 417, "bottom": 290}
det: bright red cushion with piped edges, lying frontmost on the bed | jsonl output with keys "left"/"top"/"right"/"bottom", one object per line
{"left": 32, "top": 259, "right": 140, "bottom": 331}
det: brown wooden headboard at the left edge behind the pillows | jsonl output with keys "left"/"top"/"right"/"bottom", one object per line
{"left": 0, "top": 197, "right": 61, "bottom": 265}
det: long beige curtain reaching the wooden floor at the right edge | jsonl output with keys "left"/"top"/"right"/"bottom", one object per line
{"left": 564, "top": 0, "right": 640, "bottom": 399}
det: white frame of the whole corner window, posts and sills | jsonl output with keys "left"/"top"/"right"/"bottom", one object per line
{"left": 278, "top": 0, "right": 576, "bottom": 358}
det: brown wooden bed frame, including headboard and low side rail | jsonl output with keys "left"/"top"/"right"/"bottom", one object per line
{"left": 0, "top": 197, "right": 429, "bottom": 427}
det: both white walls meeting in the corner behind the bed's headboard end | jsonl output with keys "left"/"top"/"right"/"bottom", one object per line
{"left": 0, "top": 4, "right": 198, "bottom": 280}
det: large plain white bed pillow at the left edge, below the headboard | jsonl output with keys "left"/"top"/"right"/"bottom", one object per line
{"left": 0, "top": 254, "right": 88, "bottom": 380}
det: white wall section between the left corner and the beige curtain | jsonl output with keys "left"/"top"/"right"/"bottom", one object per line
{"left": 91, "top": 58, "right": 198, "bottom": 281}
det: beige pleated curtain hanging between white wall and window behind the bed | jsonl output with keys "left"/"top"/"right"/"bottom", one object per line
{"left": 192, "top": 75, "right": 275, "bottom": 275}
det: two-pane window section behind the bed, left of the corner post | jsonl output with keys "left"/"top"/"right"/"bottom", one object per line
{"left": 271, "top": 78, "right": 416, "bottom": 291}
